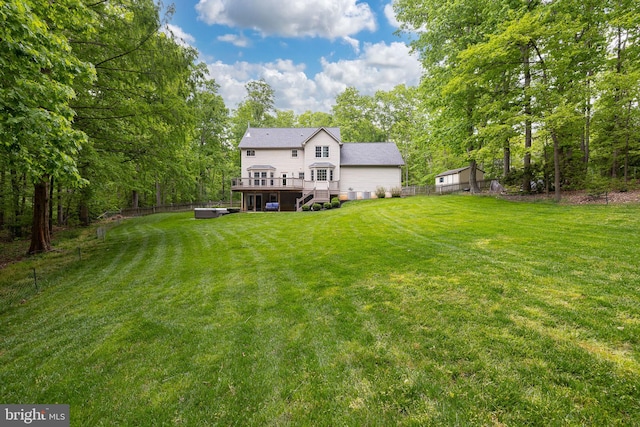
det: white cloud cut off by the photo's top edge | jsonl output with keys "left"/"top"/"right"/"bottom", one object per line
{"left": 196, "top": 0, "right": 377, "bottom": 40}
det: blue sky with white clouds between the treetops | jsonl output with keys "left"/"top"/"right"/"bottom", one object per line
{"left": 168, "top": 0, "right": 422, "bottom": 114}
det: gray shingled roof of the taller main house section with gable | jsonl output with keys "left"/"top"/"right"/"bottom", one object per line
{"left": 238, "top": 128, "right": 340, "bottom": 148}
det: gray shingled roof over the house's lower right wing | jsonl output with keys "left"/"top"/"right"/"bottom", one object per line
{"left": 340, "top": 142, "right": 404, "bottom": 166}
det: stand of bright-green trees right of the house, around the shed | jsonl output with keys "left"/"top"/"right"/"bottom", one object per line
{"left": 394, "top": 0, "right": 640, "bottom": 198}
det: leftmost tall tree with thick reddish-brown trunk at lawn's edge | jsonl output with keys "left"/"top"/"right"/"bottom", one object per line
{"left": 0, "top": 0, "right": 94, "bottom": 253}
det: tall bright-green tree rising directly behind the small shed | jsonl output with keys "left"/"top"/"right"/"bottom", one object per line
{"left": 394, "top": 0, "right": 503, "bottom": 191}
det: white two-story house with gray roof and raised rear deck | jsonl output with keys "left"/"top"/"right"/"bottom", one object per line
{"left": 231, "top": 127, "right": 404, "bottom": 211}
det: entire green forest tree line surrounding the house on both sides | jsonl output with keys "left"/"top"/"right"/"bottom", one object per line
{"left": 0, "top": 0, "right": 640, "bottom": 252}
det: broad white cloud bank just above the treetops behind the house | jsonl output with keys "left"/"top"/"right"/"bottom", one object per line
{"left": 209, "top": 42, "right": 422, "bottom": 114}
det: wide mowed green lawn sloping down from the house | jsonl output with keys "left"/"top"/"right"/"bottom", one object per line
{"left": 0, "top": 196, "right": 640, "bottom": 426}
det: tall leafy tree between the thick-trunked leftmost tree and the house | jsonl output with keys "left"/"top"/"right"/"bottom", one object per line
{"left": 73, "top": 0, "right": 196, "bottom": 217}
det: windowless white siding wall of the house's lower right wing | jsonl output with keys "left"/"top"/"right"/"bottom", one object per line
{"left": 340, "top": 166, "right": 402, "bottom": 196}
